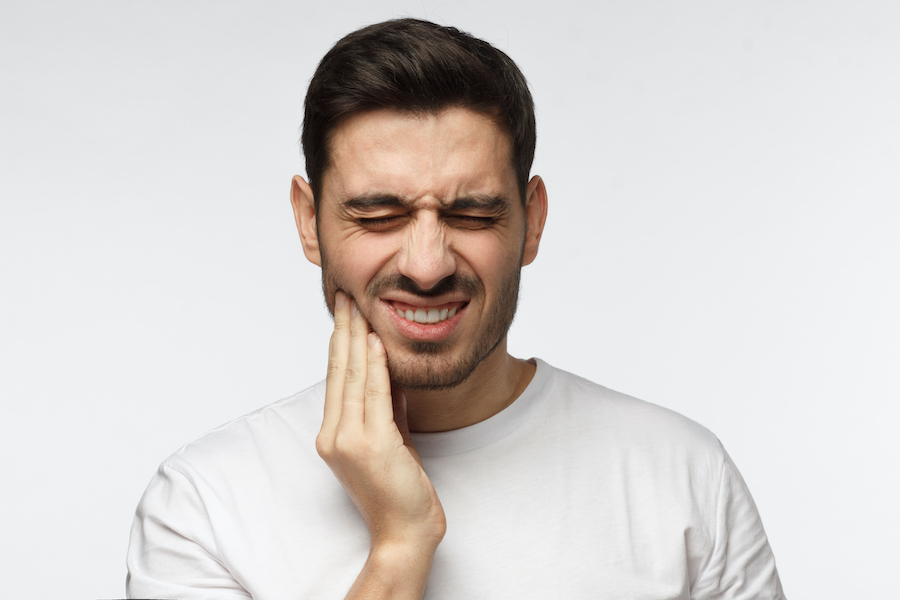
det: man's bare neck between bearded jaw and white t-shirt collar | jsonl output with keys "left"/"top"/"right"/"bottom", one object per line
{"left": 404, "top": 339, "right": 535, "bottom": 432}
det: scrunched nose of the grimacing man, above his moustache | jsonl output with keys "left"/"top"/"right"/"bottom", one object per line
{"left": 398, "top": 211, "right": 456, "bottom": 290}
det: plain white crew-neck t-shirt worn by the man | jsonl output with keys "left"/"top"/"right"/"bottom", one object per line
{"left": 127, "top": 360, "right": 784, "bottom": 600}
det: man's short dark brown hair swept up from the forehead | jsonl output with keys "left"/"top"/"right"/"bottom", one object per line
{"left": 301, "top": 19, "right": 537, "bottom": 203}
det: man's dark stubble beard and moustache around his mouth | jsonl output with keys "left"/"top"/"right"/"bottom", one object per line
{"left": 322, "top": 252, "right": 521, "bottom": 390}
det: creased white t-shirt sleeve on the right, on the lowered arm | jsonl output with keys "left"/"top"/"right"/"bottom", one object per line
{"left": 691, "top": 450, "right": 785, "bottom": 600}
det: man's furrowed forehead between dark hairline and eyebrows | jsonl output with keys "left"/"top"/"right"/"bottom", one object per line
{"left": 322, "top": 107, "right": 516, "bottom": 206}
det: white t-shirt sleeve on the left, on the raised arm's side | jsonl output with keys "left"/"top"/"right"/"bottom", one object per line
{"left": 126, "top": 463, "right": 250, "bottom": 600}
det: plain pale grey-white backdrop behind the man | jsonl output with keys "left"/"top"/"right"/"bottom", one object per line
{"left": 0, "top": 0, "right": 900, "bottom": 600}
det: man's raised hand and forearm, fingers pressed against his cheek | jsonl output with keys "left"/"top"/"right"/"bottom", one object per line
{"left": 316, "top": 291, "right": 446, "bottom": 599}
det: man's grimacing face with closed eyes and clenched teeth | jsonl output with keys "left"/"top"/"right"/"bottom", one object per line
{"left": 301, "top": 108, "right": 543, "bottom": 389}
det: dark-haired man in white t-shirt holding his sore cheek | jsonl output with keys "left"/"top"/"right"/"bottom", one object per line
{"left": 128, "top": 19, "right": 783, "bottom": 600}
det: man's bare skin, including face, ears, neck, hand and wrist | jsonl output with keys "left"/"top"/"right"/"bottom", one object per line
{"left": 291, "top": 108, "right": 547, "bottom": 598}
